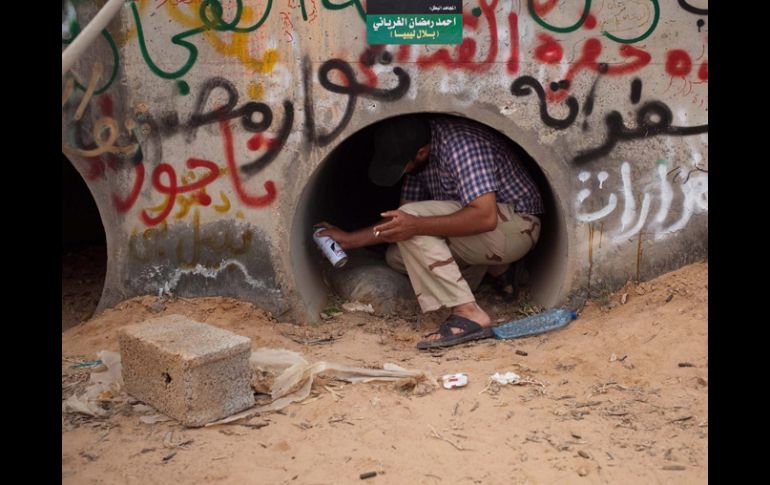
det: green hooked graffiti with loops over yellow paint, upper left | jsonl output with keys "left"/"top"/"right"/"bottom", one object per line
{"left": 131, "top": 0, "right": 273, "bottom": 79}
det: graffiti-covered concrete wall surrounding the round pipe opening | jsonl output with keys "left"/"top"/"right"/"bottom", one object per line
{"left": 62, "top": 0, "right": 708, "bottom": 320}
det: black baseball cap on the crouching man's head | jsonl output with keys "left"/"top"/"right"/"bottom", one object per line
{"left": 369, "top": 115, "right": 430, "bottom": 187}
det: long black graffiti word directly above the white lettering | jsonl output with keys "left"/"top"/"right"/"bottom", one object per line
{"left": 572, "top": 101, "right": 708, "bottom": 165}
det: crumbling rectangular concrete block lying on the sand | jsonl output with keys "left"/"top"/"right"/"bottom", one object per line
{"left": 118, "top": 315, "right": 254, "bottom": 426}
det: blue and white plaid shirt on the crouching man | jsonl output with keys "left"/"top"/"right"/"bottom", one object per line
{"left": 401, "top": 117, "right": 545, "bottom": 214}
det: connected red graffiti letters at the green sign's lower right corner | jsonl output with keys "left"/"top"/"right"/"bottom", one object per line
{"left": 417, "top": 0, "right": 499, "bottom": 72}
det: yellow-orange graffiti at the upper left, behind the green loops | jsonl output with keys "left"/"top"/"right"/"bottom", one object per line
{"left": 166, "top": 1, "right": 278, "bottom": 73}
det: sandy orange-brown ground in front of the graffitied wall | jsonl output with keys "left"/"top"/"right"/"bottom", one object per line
{"left": 62, "top": 263, "right": 708, "bottom": 484}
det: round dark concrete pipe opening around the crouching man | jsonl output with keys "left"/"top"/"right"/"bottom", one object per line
{"left": 291, "top": 114, "right": 567, "bottom": 321}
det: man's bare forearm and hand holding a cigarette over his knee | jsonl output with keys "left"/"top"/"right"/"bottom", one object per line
{"left": 372, "top": 192, "right": 497, "bottom": 242}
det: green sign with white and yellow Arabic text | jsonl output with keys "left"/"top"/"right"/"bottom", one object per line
{"left": 366, "top": 14, "right": 463, "bottom": 44}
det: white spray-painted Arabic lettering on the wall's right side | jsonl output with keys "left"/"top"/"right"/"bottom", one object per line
{"left": 575, "top": 160, "right": 708, "bottom": 244}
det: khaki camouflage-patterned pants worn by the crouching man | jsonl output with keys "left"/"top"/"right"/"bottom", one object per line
{"left": 386, "top": 200, "right": 540, "bottom": 313}
